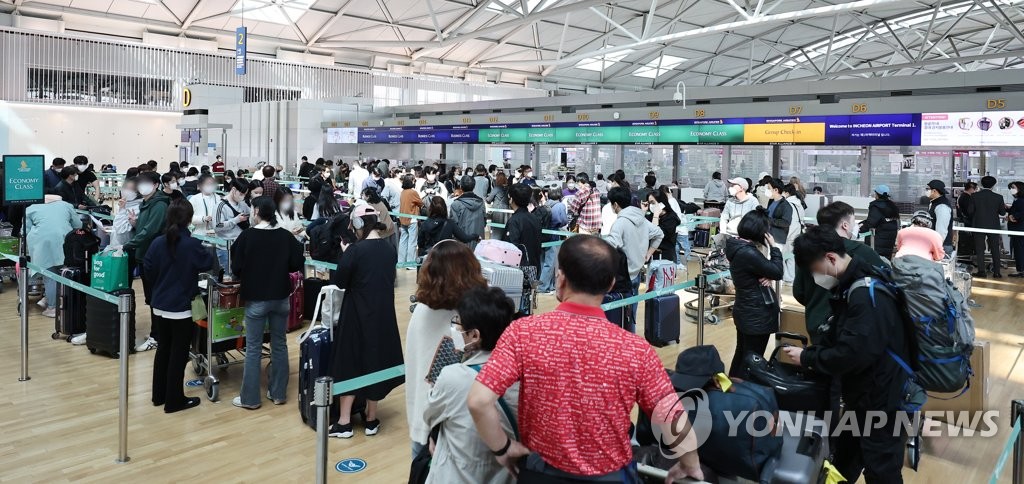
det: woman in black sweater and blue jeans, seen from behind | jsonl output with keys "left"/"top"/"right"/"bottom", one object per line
{"left": 231, "top": 196, "right": 305, "bottom": 410}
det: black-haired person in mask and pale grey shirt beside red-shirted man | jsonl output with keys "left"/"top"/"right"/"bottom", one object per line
{"left": 423, "top": 287, "right": 519, "bottom": 484}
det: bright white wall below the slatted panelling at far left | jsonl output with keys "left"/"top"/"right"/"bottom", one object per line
{"left": 0, "top": 101, "right": 180, "bottom": 172}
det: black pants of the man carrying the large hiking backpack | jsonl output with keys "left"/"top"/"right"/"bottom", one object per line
{"left": 835, "top": 410, "right": 906, "bottom": 484}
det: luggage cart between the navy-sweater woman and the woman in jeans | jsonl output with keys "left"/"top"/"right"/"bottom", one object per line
{"left": 188, "top": 273, "right": 270, "bottom": 402}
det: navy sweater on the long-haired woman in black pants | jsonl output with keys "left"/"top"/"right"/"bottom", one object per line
{"left": 142, "top": 230, "right": 213, "bottom": 312}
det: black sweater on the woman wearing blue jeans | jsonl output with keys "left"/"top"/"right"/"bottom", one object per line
{"left": 231, "top": 223, "right": 305, "bottom": 301}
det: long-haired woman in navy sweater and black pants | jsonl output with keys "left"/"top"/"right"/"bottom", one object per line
{"left": 142, "top": 200, "right": 213, "bottom": 413}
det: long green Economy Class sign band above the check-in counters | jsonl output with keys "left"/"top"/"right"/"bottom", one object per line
{"left": 479, "top": 125, "right": 743, "bottom": 144}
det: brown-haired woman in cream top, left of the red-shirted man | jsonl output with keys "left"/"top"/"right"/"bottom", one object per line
{"left": 406, "top": 238, "right": 487, "bottom": 457}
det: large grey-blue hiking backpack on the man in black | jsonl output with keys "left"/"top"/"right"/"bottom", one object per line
{"left": 847, "top": 256, "right": 974, "bottom": 396}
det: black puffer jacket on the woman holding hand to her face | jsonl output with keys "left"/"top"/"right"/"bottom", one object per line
{"left": 725, "top": 237, "right": 782, "bottom": 335}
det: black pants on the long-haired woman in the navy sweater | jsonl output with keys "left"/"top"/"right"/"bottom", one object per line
{"left": 153, "top": 316, "right": 196, "bottom": 409}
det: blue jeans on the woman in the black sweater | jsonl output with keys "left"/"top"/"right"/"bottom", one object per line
{"left": 242, "top": 298, "right": 289, "bottom": 405}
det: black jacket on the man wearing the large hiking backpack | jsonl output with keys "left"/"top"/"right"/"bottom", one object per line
{"left": 801, "top": 258, "right": 912, "bottom": 411}
